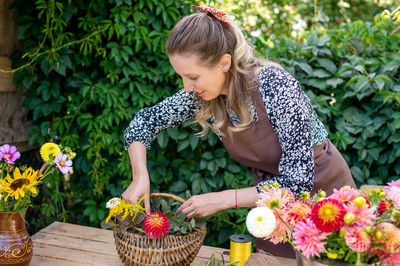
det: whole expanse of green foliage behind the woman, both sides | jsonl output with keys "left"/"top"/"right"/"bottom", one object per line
{"left": 7, "top": 0, "right": 400, "bottom": 247}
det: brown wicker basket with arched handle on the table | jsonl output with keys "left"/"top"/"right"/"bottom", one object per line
{"left": 113, "top": 193, "right": 207, "bottom": 266}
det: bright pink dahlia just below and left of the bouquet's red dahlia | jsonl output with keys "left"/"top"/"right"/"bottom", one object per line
{"left": 293, "top": 219, "right": 328, "bottom": 258}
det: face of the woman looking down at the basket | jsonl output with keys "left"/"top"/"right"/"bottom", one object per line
{"left": 169, "top": 54, "right": 231, "bottom": 101}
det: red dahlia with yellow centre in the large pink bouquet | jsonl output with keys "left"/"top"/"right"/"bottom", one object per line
{"left": 311, "top": 199, "right": 346, "bottom": 233}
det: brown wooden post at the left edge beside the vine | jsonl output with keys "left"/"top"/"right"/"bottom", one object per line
{"left": 0, "top": 0, "right": 33, "bottom": 152}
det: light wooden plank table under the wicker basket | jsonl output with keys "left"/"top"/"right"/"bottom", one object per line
{"left": 30, "top": 222, "right": 296, "bottom": 266}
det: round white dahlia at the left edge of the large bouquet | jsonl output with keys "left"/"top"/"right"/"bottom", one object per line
{"left": 246, "top": 207, "right": 276, "bottom": 238}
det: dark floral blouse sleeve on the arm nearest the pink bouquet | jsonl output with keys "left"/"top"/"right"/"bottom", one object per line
{"left": 257, "top": 67, "right": 314, "bottom": 196}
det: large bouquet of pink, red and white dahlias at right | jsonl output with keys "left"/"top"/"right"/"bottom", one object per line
{"left": 246, "top": 180, "right": 400, "bottom": 265}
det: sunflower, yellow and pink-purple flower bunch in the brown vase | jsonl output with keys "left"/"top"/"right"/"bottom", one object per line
{"left": 0, "top": 143, "right": 76, "bottom": 217}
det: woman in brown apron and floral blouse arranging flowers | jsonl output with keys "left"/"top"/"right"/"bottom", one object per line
{"left": 122, "top": 6, "right": 355, "bottom": 256}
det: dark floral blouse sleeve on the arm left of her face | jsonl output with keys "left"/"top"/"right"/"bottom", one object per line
{"left": 124, "top": 89, "right": 200, "bottom": 150}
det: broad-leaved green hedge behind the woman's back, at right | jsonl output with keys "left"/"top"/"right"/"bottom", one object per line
{"left": 259, "top": 8, "right": 400, "bottom": 185}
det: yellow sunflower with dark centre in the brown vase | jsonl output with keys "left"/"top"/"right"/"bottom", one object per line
{"left": 0, "top": 167, "right": 40, "bottom": 201}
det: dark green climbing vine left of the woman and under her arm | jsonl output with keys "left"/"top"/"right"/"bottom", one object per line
{"left": 13, "top": 0, "right": 251, "bottom": 245}
